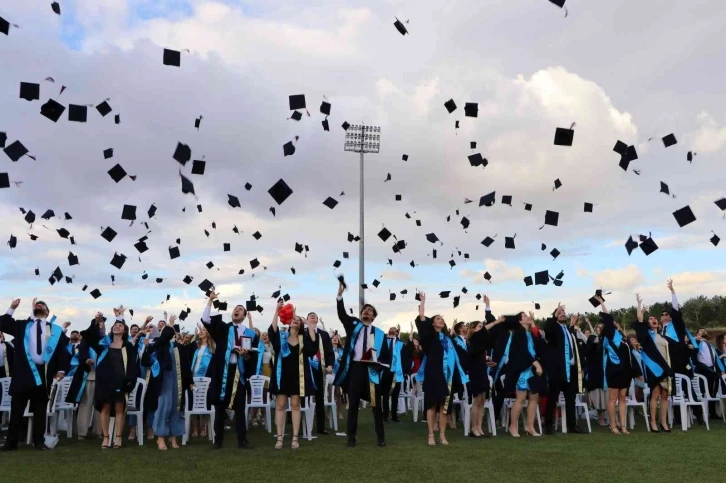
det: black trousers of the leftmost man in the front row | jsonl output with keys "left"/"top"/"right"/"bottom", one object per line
{"left": 5, "top": 365, "right": 48, "bottom": 448}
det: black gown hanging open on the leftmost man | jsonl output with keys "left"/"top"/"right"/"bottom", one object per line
{"left": 0, "top": 314, "right": 70, "bottom": 396}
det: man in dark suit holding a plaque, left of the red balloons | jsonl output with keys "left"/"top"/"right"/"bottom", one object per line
{"left": 202, "top": 291, "right": 259, "bottom": 449}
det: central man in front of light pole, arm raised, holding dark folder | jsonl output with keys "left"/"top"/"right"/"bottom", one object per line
{"left": 335, "top": 282, "right": 391, "bottom": 448}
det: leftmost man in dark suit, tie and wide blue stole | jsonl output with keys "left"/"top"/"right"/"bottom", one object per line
{"left": 0, "top": 299, "right": 70, "bottom": 451}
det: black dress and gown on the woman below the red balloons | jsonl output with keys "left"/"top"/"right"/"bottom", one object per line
{"left": 267, "top": 326, "right": 318, "bottom": 397}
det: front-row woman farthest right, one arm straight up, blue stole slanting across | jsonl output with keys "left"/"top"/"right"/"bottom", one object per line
{"left": 631, "top": 294, "right": 673, "bottom": 433}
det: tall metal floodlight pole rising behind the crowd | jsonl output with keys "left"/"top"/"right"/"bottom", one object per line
{"left": 345, "top": 124, "right": 381, "bottom": 313}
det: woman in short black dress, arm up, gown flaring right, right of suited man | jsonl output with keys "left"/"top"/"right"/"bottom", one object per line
{"left": 595, "top": 295, "right": 643, "bottom": 434}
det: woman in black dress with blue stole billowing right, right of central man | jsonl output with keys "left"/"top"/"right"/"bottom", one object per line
{"left": 416, "top": 292, "right": 469, "bottom": 446}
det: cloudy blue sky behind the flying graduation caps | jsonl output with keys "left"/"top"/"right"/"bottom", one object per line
{"left": 0, "top": 0, "right": 726, "bottom": 338}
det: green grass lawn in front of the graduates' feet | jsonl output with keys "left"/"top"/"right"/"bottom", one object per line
{"left": 0, "top": 410, "right": 726, "bottom": 483}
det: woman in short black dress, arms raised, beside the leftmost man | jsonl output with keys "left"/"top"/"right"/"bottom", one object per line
{"left": 81, "top": 306, "right": 138, "bottom": 449}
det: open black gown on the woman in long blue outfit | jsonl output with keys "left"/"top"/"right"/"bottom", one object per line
{"left": 141, "top": 326, "right": 193, "bottom": 414}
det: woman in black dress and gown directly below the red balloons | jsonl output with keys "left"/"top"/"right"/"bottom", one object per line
{"left": 267, "top": 299, "right": 318, "bottom": 449}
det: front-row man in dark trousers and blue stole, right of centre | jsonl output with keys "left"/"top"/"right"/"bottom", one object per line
{"left": 544, "top": 305, "right": 584, "bottom": 436}
